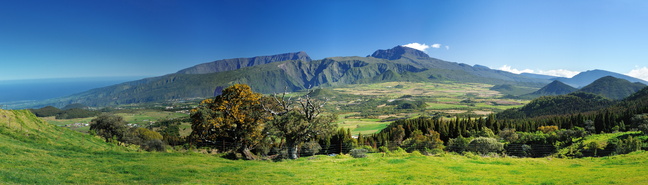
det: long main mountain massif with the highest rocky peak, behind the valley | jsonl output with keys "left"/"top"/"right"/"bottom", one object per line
{"left": 14, "top": 46, "right": 549, "bottom": 107}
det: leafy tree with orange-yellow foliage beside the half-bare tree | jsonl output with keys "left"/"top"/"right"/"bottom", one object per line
{"left": 190, "top": 84, "right": 271, "bottom": 160}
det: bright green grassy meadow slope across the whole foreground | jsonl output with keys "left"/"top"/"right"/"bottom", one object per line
{"left": 0, "top": 110, "right": 648, "bottom": 184}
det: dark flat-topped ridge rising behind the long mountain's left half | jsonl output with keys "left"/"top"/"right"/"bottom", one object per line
{"left": 177, "top": 51, "right": 311, "bottom": 74}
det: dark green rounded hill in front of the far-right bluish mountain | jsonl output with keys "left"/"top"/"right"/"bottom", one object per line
{"left": 580, "top": 76, "right": 646, "bottom": 100}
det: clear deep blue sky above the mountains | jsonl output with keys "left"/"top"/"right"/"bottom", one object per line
{"left": 0, "top": 0, "right": 648, "bottom": 80}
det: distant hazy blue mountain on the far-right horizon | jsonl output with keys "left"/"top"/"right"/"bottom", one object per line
{"left": 553, "top": 69, "right": 648, "bottom": 88}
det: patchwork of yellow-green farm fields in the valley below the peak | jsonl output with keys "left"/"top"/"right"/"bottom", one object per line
{"left": 328, "top": 82, "right": 529, "bottom": 135}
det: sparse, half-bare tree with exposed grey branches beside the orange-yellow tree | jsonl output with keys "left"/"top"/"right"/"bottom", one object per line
{"left": 263, "top": 91, "right": 336, "bottom": 159}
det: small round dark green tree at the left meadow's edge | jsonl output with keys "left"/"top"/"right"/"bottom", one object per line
{"left": 90, "top": 114, "right": 127, "bottom": 142}
